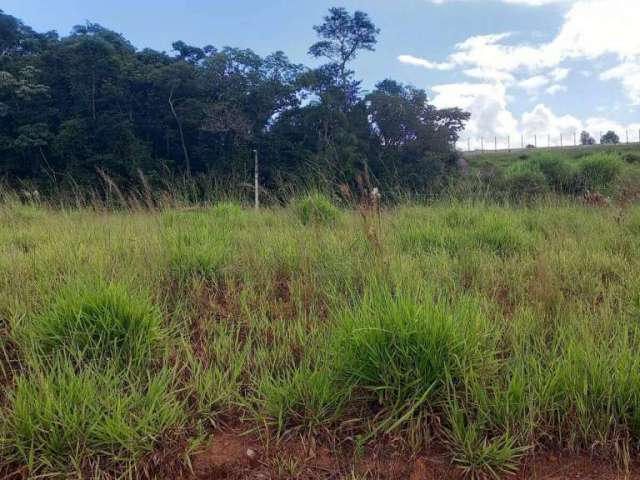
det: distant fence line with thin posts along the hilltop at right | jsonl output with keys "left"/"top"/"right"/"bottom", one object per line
{"left": 455, "top": 130, "right": 640, "bottom": 153}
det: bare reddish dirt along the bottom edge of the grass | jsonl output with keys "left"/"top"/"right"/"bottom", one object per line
{"left": 185, "top": 433, "right": 640, "bottom": 480}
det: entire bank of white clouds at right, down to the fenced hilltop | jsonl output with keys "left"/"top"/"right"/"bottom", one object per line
{"left": 398, "top": 0, "right": 640, "bottom": 142}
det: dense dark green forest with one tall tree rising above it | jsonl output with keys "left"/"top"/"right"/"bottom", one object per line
{"left": 0, "top": 8, "right": 469, "bottom": 197}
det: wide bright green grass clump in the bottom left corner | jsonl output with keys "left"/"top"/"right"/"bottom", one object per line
{"left": 0, "top": 363, "right": 184, "bottom": 478}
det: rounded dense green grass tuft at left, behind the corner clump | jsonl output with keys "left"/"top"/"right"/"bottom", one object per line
{"left": 25, "top": 282, "right": 163, "bottom": 365}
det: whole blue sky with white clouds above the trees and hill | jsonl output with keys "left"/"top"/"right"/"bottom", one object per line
{"left": 0, "top": 0, "right": 640, "bottom": 148}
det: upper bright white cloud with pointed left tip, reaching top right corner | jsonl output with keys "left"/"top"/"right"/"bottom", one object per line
{"left": 403, "top": 0, "right": 640, "bottom": 105}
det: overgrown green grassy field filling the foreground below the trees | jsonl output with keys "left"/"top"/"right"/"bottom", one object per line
{"left": 0, "top": 193, "right": 640, "bottom": 479}
